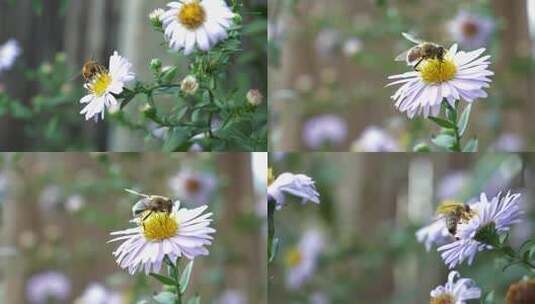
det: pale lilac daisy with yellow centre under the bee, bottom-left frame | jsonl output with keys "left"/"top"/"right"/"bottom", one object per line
{"left": 108, "top": 201, "right": 215, "bottom": 275}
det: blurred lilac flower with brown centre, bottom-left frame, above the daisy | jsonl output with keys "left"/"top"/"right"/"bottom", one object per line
{"left": 168, "top": 168, "right": 217, "bottom": 205}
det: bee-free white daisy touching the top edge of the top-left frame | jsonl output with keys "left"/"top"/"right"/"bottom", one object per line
{"left": 160, "top": 0, "right": 235, "bottom": 55}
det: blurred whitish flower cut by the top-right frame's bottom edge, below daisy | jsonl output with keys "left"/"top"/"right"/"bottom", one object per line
{"left": 351, "top": 126, "right": 400, "bottom": 152}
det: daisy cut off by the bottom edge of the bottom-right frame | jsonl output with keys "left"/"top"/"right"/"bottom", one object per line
{"left": 429, "top": 271, "right": 481, "bottom": 304}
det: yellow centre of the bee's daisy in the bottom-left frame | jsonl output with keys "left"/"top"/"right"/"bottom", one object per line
{"left": 141, "top": 211, "right": 178, "bottom": 241}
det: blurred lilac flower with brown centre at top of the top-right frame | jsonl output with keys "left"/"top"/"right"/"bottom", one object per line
{"left": 448, "top": 10, "right": 494, "bottom": 49}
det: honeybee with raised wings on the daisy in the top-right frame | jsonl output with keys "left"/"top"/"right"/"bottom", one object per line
{"left": 395, "top": 33, "right": 446, "bottom": 71}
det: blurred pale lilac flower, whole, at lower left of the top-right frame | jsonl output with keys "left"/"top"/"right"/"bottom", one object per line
{"left": 303, "top": 114, "right": 347, "bottom": 149}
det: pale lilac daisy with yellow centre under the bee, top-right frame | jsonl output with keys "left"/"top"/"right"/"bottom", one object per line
{"left": 387, "top": 44, "right": 494, "bottom": 118}
